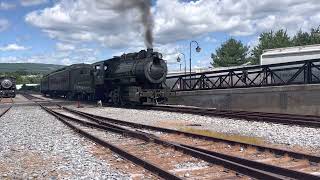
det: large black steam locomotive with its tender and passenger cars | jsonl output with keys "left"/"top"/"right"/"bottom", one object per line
{"left": 41, "top": 49, "right": 169, "bottom": 105}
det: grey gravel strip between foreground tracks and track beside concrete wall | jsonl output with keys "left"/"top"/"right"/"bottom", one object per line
{"left": 73, "top": 106, "right": 320, "bottom": 149}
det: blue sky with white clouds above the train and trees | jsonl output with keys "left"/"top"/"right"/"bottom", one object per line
{"left": 0, "top": 0, "right": 320, "bottom": 70}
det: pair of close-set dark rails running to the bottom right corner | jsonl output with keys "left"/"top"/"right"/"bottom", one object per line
{"left": 45, "top": 106, "right": 319, "bottom": 179}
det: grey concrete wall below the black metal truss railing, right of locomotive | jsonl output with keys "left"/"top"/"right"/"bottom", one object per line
{"left": 169, "top": 84, "right": 320, "bottom": 115}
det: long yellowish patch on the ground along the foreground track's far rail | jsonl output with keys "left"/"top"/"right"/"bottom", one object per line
{"left": 179, "top": 128, "right": 265, "bottom": 145}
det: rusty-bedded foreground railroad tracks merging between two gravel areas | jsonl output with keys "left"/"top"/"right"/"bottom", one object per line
{"left": 21, "top": 94, "right": 320, "bottom": 179}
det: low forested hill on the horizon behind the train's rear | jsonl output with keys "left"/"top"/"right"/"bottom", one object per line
{"left": 0, "top": 63, "right": 64, "bottom": 74}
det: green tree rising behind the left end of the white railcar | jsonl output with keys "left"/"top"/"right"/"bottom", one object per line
{"left": 251, "top": 29, "right": 292, "bottom": 64}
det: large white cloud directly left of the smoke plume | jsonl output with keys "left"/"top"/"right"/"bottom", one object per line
{"left": 25, "top": 0, "right": 143, "bottom": 48}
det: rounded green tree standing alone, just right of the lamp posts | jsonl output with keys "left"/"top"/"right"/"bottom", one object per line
{"left": 211, "top": 38, "right": 249, "bottom": 67}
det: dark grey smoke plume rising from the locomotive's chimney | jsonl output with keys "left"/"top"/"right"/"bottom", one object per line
{"left": 110, "top": 0, "right": 153, "bottom": 49}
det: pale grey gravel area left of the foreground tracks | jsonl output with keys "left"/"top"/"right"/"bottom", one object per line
{"left": 0, "top": 106, "right": 130, "bottom": 179}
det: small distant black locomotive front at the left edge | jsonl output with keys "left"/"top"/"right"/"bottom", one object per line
{"left": 0, "top": 77, "right": 16, "bottom": 98}
